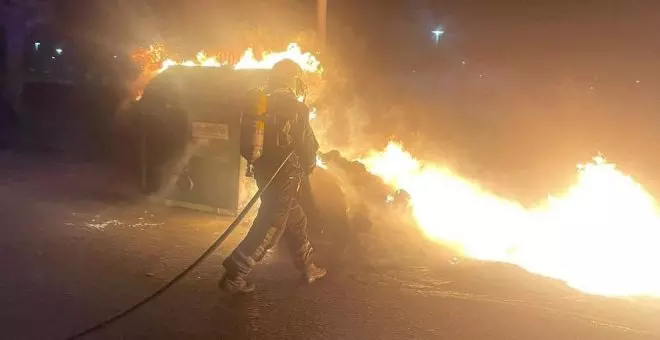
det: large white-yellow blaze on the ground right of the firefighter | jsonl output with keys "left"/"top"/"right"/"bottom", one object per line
{"left": 361, "top": 142, "right": 660, "bottom": 297}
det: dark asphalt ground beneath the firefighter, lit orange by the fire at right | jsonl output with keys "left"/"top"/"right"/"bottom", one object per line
{"left": 0, "top": 154, "right": 660, "bottom": 340}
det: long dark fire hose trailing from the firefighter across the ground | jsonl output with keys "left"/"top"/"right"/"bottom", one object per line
{"left": 67, "top": 150, "right": 293, "bottom": 340}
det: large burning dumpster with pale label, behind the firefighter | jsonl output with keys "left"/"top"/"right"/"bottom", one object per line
{"left": 136, "top": 67, "right": 267, "bottom": 215}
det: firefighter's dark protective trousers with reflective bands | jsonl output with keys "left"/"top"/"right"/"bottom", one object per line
{"left": 223, "top": 165, "right": 313, "bottom": 277}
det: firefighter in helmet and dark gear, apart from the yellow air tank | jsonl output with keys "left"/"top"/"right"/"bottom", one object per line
{"left": 219, "top": 60, "right": 327, "bottom": 294}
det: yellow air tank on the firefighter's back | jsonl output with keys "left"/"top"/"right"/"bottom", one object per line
{"left": 241, "top": 89, "right": 268, "bottom": 177}
